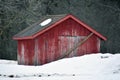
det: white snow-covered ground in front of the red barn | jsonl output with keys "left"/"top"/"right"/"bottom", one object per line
{"left": 0, "top": 53, "right": 120, "bottom": 80}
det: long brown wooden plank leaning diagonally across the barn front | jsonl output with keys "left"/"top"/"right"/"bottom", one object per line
{"left": 59, "top": 33, "right": 94, "bottom": 59}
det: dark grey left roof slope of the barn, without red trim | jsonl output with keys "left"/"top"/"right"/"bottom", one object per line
{"left": 14, "top": 14, "right": 67, "bottom": 38}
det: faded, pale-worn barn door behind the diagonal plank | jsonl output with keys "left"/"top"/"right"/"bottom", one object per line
{"left": 59, "top": 36, "right": 82, "bottom": 57}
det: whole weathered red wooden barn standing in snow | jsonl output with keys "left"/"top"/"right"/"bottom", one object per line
{"left": 13, "top": 15, "right": 107, "bottom": 65}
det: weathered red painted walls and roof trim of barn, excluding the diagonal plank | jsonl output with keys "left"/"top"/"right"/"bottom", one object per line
{"left": 14, "top": 15, "right": 106, "bottom": 65}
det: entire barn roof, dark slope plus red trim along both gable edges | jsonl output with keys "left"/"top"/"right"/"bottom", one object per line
{"left": 13, "top": 14, "right": 107, "bottom": 40}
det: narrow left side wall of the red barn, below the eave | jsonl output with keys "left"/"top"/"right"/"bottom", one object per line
{"left": 18, "top": 40, "right": 34, "bottom": 65}
